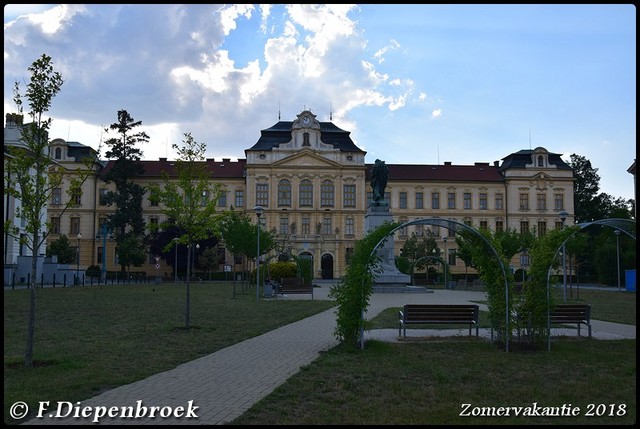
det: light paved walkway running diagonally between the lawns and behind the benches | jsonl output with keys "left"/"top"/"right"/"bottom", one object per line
{"left": 25, "top": 285, "right": 636, "bottom": 425}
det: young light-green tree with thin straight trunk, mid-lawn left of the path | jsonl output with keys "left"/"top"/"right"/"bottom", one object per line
{"left": 149, "top": 133, "right": 222, "bottom": 328}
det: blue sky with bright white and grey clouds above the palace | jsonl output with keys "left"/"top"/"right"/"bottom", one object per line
{"left": 4, "top": 4, "right": 636, "bottom": 199}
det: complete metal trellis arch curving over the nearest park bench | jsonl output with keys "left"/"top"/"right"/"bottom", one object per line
{"left": 360, "top": 218, "right": 509, "bottom": 352}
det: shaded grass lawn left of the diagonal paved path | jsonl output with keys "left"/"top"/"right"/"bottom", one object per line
{"left": 4, "top": 282, "right": 335, "bottom": 423}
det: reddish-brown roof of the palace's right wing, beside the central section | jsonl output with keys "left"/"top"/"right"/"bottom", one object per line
{"left": 365, "top": 162, "right": 504, "bottom": 182}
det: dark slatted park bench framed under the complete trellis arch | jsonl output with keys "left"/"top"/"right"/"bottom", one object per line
{"left": 398, "top": 304, "right": 478, "bottom": 337}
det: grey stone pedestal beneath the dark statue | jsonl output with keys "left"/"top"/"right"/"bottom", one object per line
{"left": 364, "top": 205, "right": 411, "bottom": 291}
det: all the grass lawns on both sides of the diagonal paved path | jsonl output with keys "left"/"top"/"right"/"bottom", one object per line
{"left": 4, "top": 283, "right": 636, "bottom": 425}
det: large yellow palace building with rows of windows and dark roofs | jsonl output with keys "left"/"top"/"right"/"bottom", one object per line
{"left": 5, "top": 110, "right": 574, "bottom": 279}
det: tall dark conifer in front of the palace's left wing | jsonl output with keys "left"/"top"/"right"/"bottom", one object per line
{"left": 104, "top": 110, "right": 149, "bottom": 273}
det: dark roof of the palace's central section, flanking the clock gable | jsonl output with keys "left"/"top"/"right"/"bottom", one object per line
{"left": 245, "top": 121, "right": 364, "bottom": 153}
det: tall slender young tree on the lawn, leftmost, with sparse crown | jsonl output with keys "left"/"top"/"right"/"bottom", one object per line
{"left": 4, "top": 54, "right": 95, "bottom": 367}
